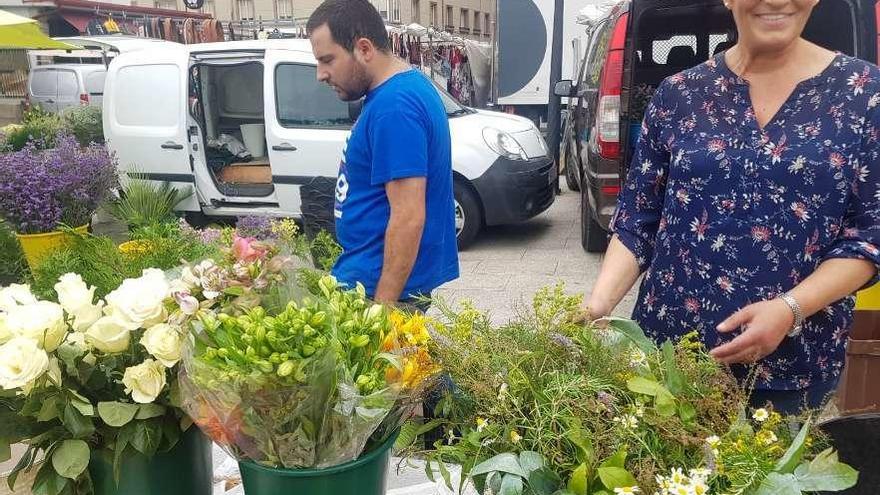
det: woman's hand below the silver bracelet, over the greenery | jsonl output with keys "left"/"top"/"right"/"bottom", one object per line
{"left": 710, "top": 299, "right": 794, "bottom": 364}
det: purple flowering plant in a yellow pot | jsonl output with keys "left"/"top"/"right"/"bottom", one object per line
{"left": 0, "top": 134, "right": 117, "bottom": 269}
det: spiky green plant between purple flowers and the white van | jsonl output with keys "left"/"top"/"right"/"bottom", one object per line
{"left": 107, "top": 174, "right": 193, "bottom": 229}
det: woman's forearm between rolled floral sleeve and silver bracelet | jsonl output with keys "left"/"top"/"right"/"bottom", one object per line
{"left": 790, "top": 258, "right": 877, "bottom": 317}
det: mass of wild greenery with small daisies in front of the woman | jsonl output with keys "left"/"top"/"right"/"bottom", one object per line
{"left": 427, "top": 286, "right": 858, "bottom": 495}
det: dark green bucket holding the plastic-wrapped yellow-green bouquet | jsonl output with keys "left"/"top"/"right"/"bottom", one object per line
{"left": 238, "top": 433, "right": 397, "bottom": 495}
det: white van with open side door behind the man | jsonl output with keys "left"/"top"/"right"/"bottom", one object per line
{"left": 103, "top": 40, "right": 557, "bottom": 247}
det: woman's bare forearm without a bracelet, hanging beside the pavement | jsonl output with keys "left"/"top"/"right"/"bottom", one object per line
{"left": 587, "top": 235, "right": 641, "bottom": 318}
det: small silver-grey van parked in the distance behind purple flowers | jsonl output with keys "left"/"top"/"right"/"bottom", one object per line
{"left": 28, "top": 64, "right": 107, "bottom": 113}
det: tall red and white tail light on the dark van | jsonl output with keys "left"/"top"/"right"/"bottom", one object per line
{"left": 596, "top": 14, "right": 629, "bottom": 160}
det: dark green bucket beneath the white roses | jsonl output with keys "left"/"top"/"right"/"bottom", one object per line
{"left": 89, "top": 426, "right": 214, "bottom": 495}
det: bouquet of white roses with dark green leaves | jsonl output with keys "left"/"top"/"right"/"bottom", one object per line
{"left": 0, "top": 269, "right": 192, "bottom": 495}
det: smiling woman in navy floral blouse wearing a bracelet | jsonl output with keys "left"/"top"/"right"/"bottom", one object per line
{"left": 587, "top": 0, "right": 880, "bottom": 412}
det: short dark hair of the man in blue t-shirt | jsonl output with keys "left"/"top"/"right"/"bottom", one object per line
{"left": 306, "top": 0, "right": 391, "bottom": 53}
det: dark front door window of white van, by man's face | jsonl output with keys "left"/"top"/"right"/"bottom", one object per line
{"left": 275, "top": 64, "right": 351, "bottom": 129}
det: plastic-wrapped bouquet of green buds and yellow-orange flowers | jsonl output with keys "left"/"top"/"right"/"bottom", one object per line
{"left": 181, "top": 276, "right": 437, "bottom": 468}
